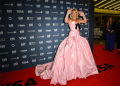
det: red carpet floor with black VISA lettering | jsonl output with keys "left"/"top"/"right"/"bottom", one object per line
{"left": 0, "top": 44, "right": 120, "bottom": 86}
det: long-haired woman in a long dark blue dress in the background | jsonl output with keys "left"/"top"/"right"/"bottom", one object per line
{"left": 103, "top": 17, "right": 116, "bottom": 51}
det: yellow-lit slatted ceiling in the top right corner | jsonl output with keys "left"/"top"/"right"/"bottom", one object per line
{"left": 93, "top": 0, "right": 120, "bottom": 11}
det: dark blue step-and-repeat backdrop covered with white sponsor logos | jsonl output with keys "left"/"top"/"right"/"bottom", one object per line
{"left": 0, "top": 0, "right": 94, "bottom": 73}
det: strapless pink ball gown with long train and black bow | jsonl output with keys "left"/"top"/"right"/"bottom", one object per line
{"left": 35, "top": 21, "right": 98, "bottom": 85}
